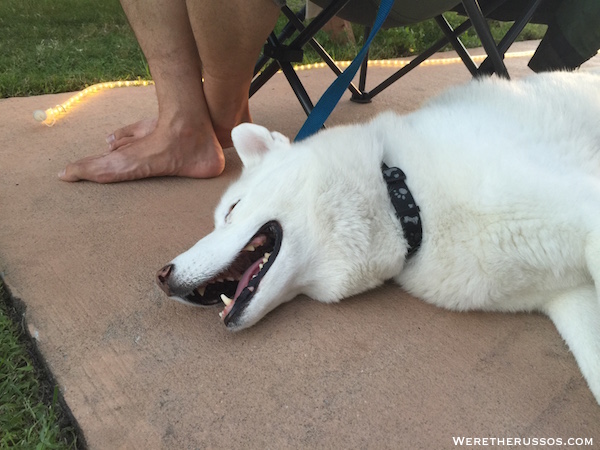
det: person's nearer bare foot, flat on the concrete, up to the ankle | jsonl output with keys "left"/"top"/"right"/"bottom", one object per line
{"left": 59, "top": 122, "right": 225, "bottom": 183}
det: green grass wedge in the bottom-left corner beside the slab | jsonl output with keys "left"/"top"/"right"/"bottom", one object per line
{"left": 0, "top": 280, "right": 77, "bottom": 450}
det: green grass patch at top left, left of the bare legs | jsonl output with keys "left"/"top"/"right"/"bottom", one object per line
{"left": 0, "top": 0, "right": 149, "bottom": 98}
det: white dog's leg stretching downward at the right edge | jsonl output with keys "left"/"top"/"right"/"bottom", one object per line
{"left": 544, "top": 285, "right": 600, "bottom": 404}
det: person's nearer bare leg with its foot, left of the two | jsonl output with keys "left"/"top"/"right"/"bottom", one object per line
{"left": 60, "top": 0, "right": 224, "bottom": 183}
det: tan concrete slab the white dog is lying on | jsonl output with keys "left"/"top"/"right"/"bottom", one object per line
{"left": 0, "top": 44, "right": 600, "bottom": 449}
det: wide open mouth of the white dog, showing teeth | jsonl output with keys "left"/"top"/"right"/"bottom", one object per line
{"left": 185, "top": 221, "right": 283, "bottom": 325}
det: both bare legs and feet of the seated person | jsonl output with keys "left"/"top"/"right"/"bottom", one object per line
{"left": 59, "top": 0, "right": 278, "bottom": 182}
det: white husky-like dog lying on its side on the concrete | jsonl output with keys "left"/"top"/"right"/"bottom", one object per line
{"left": 157, "top": 73, "right": 600, "bottom": 403}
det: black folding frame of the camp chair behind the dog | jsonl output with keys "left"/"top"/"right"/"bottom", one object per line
{"left": 250, "top": 0, "right": 543, "bottom": 114}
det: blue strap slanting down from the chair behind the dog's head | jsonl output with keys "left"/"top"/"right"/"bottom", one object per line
{"left": 294, "top": 0, "right": 394, "bottom": 141}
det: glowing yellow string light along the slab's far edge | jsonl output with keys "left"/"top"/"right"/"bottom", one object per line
{"left": 33, "top": 51, "right": 533, "bottom": 127}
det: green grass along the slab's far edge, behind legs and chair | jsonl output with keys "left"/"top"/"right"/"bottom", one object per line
{"left": 0, "top": 0, "right": 545, "bottom": 98}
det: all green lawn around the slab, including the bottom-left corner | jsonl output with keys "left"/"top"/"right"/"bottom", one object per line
{"left": 0, "top": 0, "right": 545, "bottom": 449}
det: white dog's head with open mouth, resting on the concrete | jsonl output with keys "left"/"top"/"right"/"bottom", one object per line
{"left": 157, "top": 124, "right": 405, "bottom": 330}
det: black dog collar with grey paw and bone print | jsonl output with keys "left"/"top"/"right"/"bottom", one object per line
{"left": 381, "top": 163, "right": 423, "bottom": 259}
